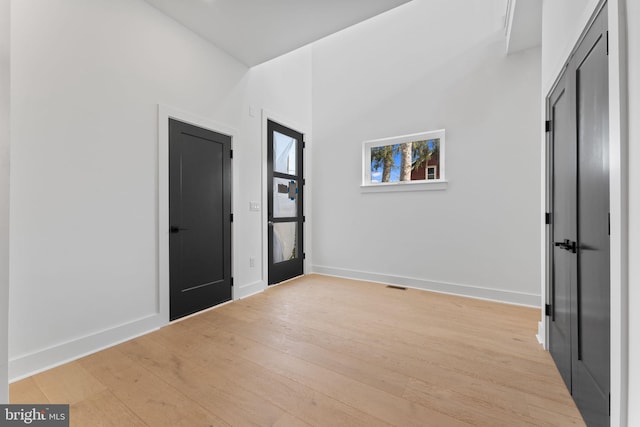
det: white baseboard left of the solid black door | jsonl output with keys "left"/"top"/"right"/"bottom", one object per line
{"left": 9, "top": 314, "right": 167, "bottom": 382}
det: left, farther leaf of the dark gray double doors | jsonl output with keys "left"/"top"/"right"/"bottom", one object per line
{"left": 549, "top": 71, "right": 578, "bottom": 390}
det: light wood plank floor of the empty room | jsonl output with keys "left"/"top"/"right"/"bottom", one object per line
{"left": 10, "top": 275, "right": 584, "bottom": 427}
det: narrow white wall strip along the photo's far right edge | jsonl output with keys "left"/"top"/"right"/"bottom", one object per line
{"left": 626, "top": 0, "right": 640, "bottom": 426}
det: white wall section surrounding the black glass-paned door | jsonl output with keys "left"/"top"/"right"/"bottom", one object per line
{"left": 234, "top": 46, "right": 312, "bottom": 297}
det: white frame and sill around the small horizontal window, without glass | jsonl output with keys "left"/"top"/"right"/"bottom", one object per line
{"left": 360, "top": 129, "right": 448, "bottom": 193}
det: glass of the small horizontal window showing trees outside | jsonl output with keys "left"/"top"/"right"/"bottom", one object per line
{"left": 371, "top": 138, "right": 440, "bottom": 183}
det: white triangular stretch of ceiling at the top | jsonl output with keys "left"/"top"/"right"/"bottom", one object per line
{"left": 146, "top": 0, "right": 411, "bottom": 67}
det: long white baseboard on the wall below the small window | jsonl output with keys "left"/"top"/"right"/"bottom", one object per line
{"left": 312, "top": 265, "right": 540, "bottom": 308}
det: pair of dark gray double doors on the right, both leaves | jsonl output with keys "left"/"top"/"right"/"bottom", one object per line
{"left": 547, "top": 4, "right": 610, "bottom": 426}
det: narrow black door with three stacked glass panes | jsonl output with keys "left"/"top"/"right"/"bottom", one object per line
{"left": 267, "top": 120, "right": 304, "bottom": 285}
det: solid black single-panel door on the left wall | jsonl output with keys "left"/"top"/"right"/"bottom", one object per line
{"left": 169, "top": 119, "right": 232, "bottom": 320}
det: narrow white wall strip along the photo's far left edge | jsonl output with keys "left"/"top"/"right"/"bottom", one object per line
{"left": 0, "top": 0, "right": 10, "bottom": 404}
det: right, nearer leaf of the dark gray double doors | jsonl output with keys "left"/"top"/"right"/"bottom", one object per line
{"left": 572, "top": 8, "right": 610, "bottom": 426}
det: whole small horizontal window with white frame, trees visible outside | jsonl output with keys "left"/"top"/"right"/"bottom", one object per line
{"left": 362, "top": 129, "right": 446, "bottom": 191}
